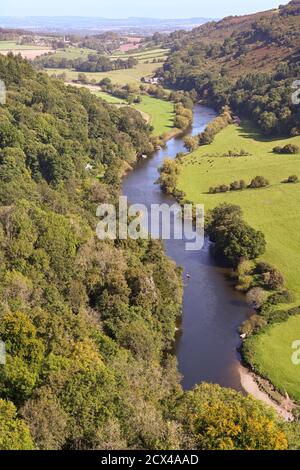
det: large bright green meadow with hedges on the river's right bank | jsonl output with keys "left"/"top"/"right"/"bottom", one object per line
{"left": 178, "top": 124, "right": 300, "bottom": 401}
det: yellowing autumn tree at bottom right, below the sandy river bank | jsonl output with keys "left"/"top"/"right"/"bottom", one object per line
{"left": 178, "top": 384, "right": 288, "bottom": 450}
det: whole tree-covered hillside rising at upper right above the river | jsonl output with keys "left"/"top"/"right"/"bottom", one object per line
{"left": 159, "top": 0, "right": 300, "bottom": 136}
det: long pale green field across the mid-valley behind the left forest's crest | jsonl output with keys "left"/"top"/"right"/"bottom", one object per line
{"left": 45, "top": 63, "right": 159, "bottom": 84}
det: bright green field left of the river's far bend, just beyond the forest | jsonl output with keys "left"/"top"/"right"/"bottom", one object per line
{"left": 96, "top": 92, "right": 175, "bottom": 136}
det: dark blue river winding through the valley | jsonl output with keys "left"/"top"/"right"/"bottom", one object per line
{"left": 123, "top": 105, "right": 249, "bottom": 391}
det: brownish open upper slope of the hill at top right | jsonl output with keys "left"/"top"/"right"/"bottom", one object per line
{"left": 163, "top": 0, "right": 300, "bottom": 77}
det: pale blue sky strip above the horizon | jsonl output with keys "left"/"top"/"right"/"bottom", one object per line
{"left": 0, "top": 0, "right": 288, "bottom": 18}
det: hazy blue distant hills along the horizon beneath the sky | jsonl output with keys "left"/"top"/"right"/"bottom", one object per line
{"left": 0, "top": 16, "right": 211, "bottom": 34}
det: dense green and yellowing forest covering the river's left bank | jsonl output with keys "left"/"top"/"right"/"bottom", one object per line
{"left": 0, "top": 55, "right": 299, "bottom": 449}
